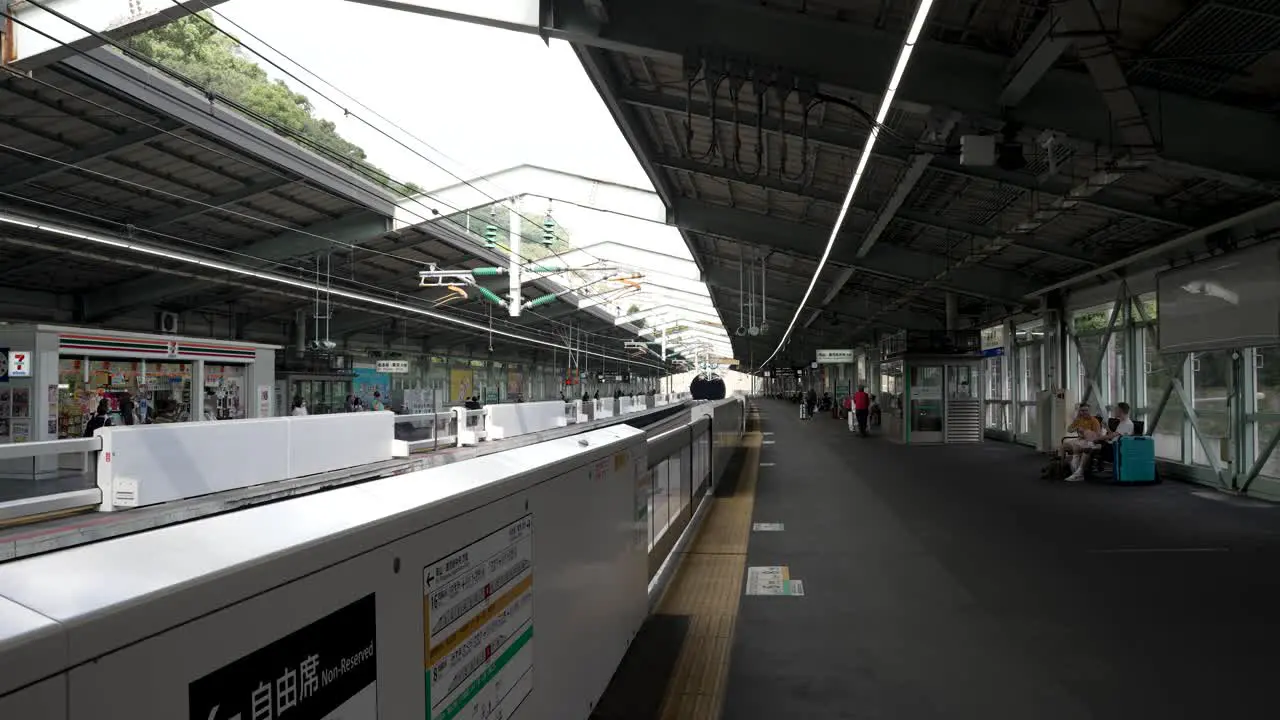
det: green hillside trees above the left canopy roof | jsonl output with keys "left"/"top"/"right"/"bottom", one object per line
{"left": 125, "top": 13, "right": 421, "bottom": 193}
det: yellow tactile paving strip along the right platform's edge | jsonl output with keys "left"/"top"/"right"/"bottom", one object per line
{"left": 658, "top": 416, "right": 762, "bottom": 720}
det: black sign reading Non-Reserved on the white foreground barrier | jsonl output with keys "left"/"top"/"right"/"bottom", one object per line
{"left": 187, "top": 594, "right": 378, "bottom": 720}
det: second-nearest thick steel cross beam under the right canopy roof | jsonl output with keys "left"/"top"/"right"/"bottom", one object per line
{"left": 671, "top": 199, "right": 1034, "bottom": 304}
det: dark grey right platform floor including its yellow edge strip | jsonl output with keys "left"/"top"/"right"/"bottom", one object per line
{"left": 595, "top": 400, "right": 1280, "bottom": 720}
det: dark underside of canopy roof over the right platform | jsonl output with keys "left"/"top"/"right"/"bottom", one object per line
{"left": 356, "top": 0, "right": 1280, "bottom": 360}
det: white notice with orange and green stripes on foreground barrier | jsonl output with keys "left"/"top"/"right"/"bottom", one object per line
{"left": 422, "top": 515, "right": 534, "bottom": 720}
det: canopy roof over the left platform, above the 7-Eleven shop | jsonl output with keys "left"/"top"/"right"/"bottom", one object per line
{"left": 0, "top": 47, "right": 684, "bottom": 372}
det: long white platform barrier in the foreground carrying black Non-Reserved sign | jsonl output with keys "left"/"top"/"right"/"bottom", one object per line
{"left": 0, "top": 392, "right": 745, "bottom": 720}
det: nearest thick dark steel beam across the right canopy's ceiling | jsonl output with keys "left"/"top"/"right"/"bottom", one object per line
{"left": 544, "top": 0, "right": 1280, "bottom": 179}
